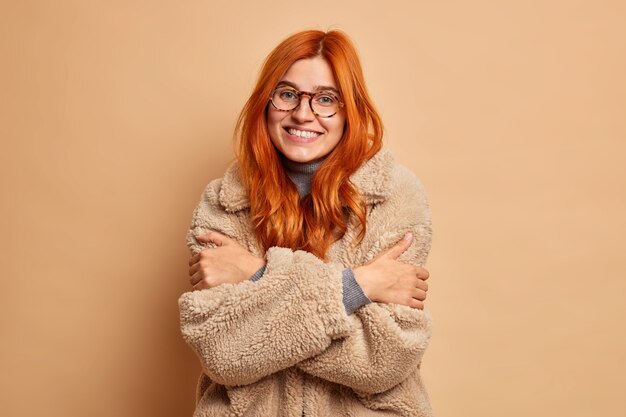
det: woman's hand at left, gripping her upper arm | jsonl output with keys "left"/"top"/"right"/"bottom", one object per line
{"left": 189, "top": 232, "right": 265, "bottom": 290}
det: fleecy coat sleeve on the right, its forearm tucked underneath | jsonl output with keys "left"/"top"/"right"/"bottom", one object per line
{"left": 297, "top": 168, "right": 431, "bottom": 394}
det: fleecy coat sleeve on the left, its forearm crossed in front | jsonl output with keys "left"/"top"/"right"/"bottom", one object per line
{"left": 179, "top": 180, "right": 352, "bottom": 385}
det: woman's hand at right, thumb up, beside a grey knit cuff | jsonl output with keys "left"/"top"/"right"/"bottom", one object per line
{"left": 353, "top": 233, "right": 430, "bottom": 309}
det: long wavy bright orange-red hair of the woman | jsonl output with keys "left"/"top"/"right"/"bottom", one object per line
{"left": 234, "top": 30, "right": 383, "bottom": 259}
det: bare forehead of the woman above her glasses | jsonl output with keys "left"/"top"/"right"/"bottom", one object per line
{"left": 280, "top": 57, "right": 337, "bottom": 91}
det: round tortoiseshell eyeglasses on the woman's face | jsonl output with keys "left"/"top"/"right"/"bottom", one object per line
{"left": 270, "top": 85, "right": 343, "bottom": 117}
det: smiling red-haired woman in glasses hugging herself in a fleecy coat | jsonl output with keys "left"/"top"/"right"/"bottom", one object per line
{"left": 179, "top": 31, "right": 432, "bottom": 417}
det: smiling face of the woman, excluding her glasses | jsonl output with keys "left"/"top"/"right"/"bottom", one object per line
{"left": 267, "top": 57, "right": 346, "bottom": 162}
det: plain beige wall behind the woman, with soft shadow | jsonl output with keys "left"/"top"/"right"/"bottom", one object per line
{"left": 0, "top": 0, "right": 626, "bottom": 417}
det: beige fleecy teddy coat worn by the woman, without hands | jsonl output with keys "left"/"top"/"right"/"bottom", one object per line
{"left": 179, "top": 150, "right": 432, "bottom": 417}
